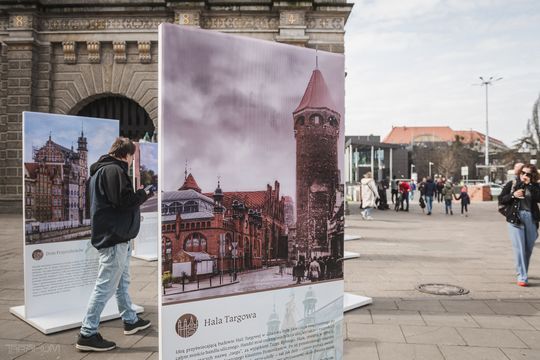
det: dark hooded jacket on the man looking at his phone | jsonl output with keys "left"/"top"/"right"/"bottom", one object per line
{"left": 88, "top": 155, "right": 148, "bottom": 249}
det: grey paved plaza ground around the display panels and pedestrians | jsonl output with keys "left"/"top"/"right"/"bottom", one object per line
{"left": 0, "top": 202, "right": 540, "bottom": 360}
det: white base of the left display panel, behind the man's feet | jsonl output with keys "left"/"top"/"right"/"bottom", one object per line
{"left": 9, "top": 301, "right": 144, "bottom": 334}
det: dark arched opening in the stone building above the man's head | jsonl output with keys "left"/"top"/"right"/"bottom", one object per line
{"left": 77, "top": 95, "right": 155, "bottom": 141}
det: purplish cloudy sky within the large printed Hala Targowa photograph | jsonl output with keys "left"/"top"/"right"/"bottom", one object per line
{"left": 160, "top": 25, "right": 345, "bottom": 199}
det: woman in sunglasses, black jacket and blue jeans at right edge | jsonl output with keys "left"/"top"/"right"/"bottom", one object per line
{"left": 499, "top": 164, "right": 540, "bottom": 286}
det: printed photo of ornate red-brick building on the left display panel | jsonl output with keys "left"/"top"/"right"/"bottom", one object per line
{"left": 23, "top": 112, "right": 118, "bottom": 245}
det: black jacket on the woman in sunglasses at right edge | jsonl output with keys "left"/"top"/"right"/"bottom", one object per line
{"left": 499, "top": 180, "right": 540, "bottom": 227}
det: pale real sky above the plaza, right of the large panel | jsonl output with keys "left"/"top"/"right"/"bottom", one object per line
{"left": 345, "top": 0, "right": 540, "bottom": 145}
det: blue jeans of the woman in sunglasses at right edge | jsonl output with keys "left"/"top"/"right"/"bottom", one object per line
{"left": 508, "top": 210, "right": 538, "bottom": 282}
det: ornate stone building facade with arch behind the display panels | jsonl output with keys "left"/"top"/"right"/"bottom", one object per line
{"left": 0, "top": 0, "right": 352, "bottom": 212}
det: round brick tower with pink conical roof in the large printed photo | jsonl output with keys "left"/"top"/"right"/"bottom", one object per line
{"left": 293, "top": 69, "right": 341, "bottom": 257}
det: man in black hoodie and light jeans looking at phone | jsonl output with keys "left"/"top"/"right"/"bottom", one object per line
{"left": 75, "top": 137, "right": 152, "bottom": 351}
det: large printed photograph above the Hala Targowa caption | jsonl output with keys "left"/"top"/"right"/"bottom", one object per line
{"left": 159, "top": 24, "right": 344, "bottom": 304}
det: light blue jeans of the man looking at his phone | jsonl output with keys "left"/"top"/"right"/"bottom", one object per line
{"left": 81, "top": 242, "right": 137, "bottom": 336}
